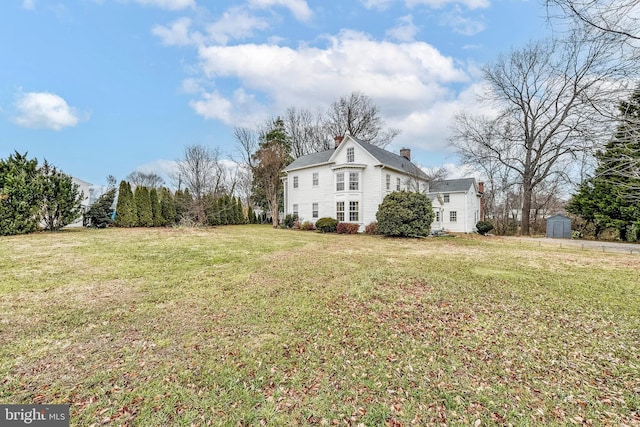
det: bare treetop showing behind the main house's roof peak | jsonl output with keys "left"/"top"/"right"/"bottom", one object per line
{"left": 324, "top": 92, "right": 400, "bottom": 148}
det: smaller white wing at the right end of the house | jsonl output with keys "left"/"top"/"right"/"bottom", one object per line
{"left": 427, "top": 178, "right": 484, "bottom": 233}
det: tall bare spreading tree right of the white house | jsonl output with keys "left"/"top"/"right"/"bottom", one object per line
{"left": 450, "top": 31, "right": 625, "bottom": 235}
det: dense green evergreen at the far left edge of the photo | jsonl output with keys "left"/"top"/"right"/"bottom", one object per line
{"left": 0, "top": 151, "right": 43, "bottom": 236}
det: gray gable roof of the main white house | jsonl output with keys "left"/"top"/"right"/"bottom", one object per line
{"left": 284, "top": 135, "right": 427, "bottom": 179}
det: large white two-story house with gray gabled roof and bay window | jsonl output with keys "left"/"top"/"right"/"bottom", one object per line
{"left": 282, "top": 135, "right": 480, "bottom": 232}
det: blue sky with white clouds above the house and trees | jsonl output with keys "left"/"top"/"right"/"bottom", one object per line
{"left": 0, "top": 0, "right": 550, "bottom": 185}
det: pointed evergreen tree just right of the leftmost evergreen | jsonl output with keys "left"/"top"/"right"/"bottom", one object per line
{"left": 40, "top": 160, "right": 83, "bottom": 231}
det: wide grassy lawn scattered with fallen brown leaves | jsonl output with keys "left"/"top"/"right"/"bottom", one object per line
{"left": 0, "top": 226, "right": 640, "bottom": 426}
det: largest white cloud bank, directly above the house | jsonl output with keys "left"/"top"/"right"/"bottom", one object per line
{"left": 183, "top": 31, "right": 478, "bottom": 149}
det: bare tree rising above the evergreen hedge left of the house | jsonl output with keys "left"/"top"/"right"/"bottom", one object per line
{"left": 175, "top": 145, "right": 226, "bottom": 224}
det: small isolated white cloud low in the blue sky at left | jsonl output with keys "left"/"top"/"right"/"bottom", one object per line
{"left": 14, "top": 92, "right": 86, "bottom": 130}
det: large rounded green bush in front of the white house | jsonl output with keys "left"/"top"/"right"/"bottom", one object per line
{"left": 376, "top": 191, "right": 434, "bottom": 237}
